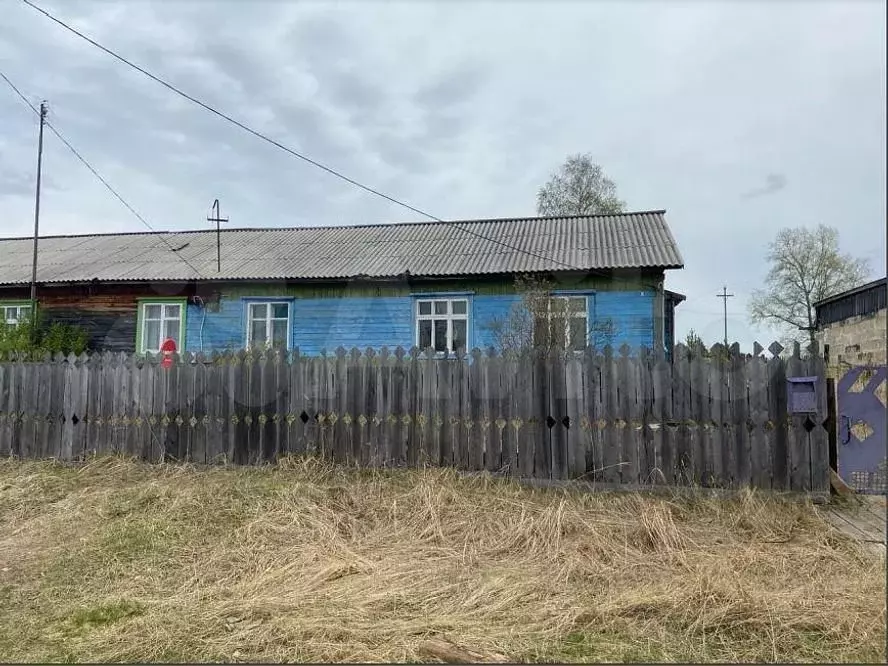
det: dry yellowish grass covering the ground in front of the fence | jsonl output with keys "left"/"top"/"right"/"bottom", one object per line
{"left": 0, "top": 459, "right": 886, "bottom": 662}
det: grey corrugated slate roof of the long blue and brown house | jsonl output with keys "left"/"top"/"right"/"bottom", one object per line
{"left": 0, "top": 211, "right": 684, "bottom": 284}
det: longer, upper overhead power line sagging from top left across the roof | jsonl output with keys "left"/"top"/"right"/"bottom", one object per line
{"left": 22, "top": 0, "right": 604, "bottom": 271}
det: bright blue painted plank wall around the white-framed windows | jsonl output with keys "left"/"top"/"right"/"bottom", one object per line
{"left": 185, "top": 287, "right": 654, "bottom": 355}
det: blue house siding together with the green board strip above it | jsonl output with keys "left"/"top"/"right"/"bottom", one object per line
{"left": 185, "top": 281, "right": 665, "bottom": 355}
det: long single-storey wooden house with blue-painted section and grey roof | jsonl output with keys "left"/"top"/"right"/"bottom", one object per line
{"left": 0, "top": 210, "right": 684, "bottom": 354}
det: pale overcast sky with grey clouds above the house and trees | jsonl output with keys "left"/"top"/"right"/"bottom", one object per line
{"left": 0, "top": 0, "right": 886, "bottom": 347}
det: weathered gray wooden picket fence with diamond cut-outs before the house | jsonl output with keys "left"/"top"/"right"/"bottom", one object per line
{"left": 0, "top": 345, "right": 829, "bottom": 492}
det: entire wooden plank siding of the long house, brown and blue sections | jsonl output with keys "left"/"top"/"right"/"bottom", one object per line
{"left": 0, "top": 270, "right": 666, "bottom": 355}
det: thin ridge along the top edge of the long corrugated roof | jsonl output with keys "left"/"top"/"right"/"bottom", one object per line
{"left": 0, "top": 209, "right": 666, "bottom": 242}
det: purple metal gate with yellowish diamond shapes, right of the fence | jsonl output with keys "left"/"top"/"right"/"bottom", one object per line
{"left": 836, "top": 365, "right": 888, "bottom": 494}
